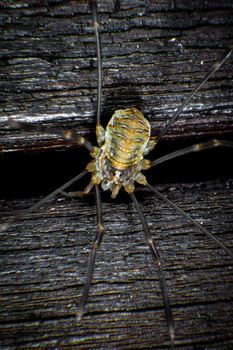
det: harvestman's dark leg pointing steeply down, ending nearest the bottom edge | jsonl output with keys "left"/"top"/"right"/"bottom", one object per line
{"left": 129, "top": 193, "right": 175, "bottom": 347}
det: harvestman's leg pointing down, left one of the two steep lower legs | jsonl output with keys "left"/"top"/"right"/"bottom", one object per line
{"left": 76, "top": 185, "right": 104, "bottom": 323}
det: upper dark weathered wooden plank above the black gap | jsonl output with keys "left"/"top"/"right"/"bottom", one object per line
{"left": 0, "top": 0, "right": 233, "bottom": 151}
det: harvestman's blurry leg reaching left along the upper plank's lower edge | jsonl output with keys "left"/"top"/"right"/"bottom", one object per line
{"left": 7, "top": 118, "right": 93, "bottom": 152}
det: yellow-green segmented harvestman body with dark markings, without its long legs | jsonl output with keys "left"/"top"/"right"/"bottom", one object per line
{"left": 87, "top": 108, "right": 155, "bottom": 198}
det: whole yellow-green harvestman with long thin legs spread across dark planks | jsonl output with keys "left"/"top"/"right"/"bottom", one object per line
{"left": 0, "top": 0, "right": 233, "bottom": 346}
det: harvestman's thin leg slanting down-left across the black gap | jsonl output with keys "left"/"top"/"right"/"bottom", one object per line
{"left": 0, "top": 170, "right": 88, "bottom": 232}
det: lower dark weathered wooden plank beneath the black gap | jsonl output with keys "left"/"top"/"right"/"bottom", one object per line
{"left": 0, "top": 181, "right": 233, "bottom": 349}
